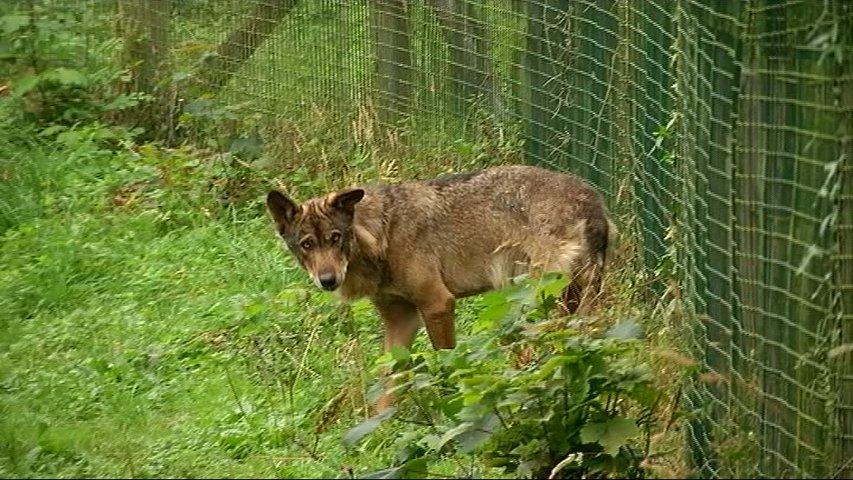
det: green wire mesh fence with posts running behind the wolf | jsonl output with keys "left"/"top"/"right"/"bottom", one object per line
{"left": 15, "top": 0, "right": 853, "bottom": 478}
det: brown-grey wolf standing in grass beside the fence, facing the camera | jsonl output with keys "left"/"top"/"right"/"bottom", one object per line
{"left": 266, "top": 165, "right": 616, "bottom": 410}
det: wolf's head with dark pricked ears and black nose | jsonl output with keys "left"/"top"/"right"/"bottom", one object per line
{"left": 267, "top": 188, "right": 364, "bottom": 291}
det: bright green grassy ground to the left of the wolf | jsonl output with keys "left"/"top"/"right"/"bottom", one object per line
{"left": 0, "top": 117, "right": 692, "bottom": 478}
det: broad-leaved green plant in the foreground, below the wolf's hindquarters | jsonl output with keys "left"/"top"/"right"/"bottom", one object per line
{"left": 343, "top": 274, "right": 680, "bottom": 478}
